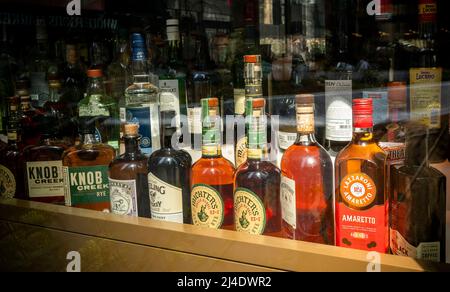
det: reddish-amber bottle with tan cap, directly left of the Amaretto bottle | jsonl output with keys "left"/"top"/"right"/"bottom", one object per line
{"left": 281, "top": 94, "right": 334, "bottom": 245}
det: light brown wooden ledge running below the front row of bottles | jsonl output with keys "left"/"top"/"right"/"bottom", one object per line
{"left": 0, "top": 200, "right": 450, "bottom": 272}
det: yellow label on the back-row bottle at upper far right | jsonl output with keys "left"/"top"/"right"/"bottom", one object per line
{"left": 410, "top": 68, "right": 442, "bottom": 129}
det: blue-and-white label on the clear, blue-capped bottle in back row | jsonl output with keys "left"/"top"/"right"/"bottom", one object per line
{"left": 126, "top": 104, "right": 161, "bottom": 156}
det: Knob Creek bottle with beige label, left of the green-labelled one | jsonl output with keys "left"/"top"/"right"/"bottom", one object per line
{"left": 23, "top": 116, "right": 68, "bottom": 205}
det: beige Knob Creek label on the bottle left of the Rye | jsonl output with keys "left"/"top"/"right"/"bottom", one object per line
{"left": 26, "top": 161, "right": 64, "bottom": 198}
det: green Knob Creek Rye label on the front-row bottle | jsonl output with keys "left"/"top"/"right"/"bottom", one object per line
{"left": 63, "top": 165, "right": 110, "bottom": 212}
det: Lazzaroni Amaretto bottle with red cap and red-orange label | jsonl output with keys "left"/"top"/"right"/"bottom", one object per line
{"left": 335, "top": 98, "right": 389, "bottom": 253}
